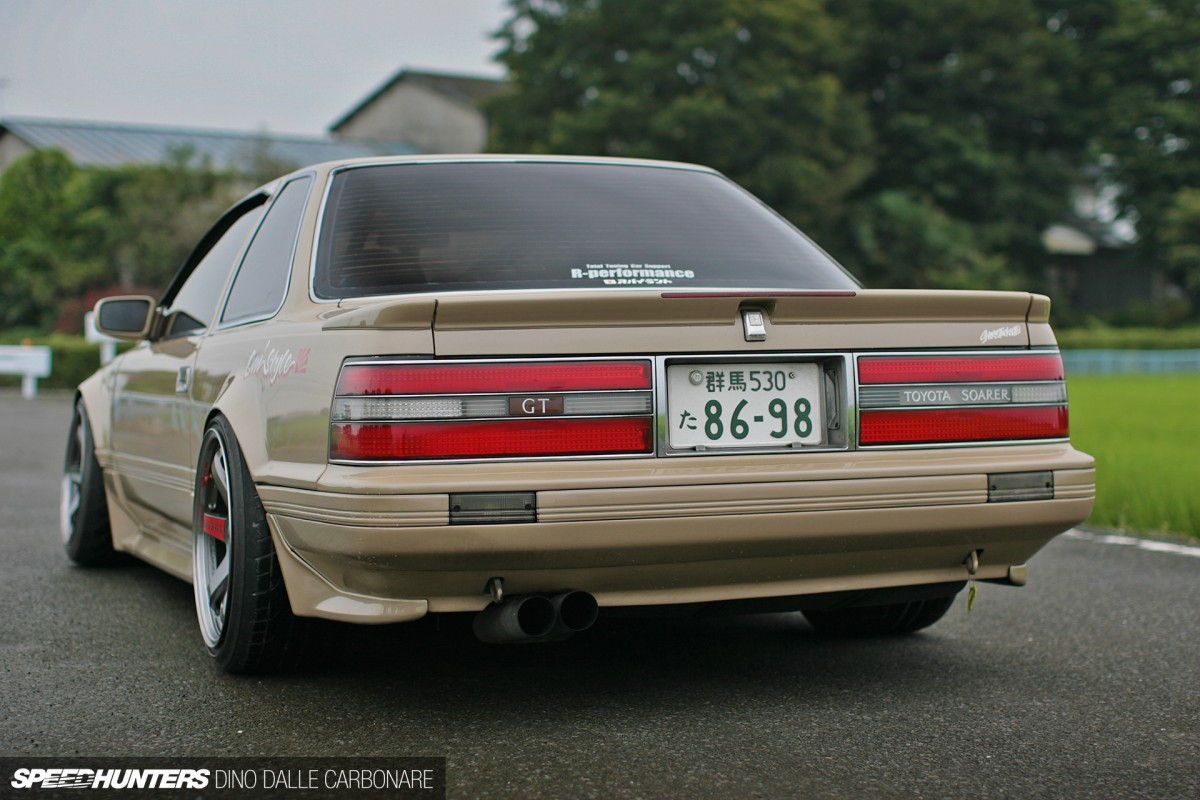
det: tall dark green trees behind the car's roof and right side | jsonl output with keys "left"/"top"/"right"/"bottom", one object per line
{"left": 491, "top": 0, "right": 1200, "bottom": 307}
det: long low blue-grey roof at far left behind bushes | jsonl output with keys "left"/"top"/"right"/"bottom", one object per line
{"left": 0, "top": 118, "right": 420, "bottom": 170}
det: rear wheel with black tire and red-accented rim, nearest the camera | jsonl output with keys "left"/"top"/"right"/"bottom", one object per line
{"left": 192, "top": 417, "right": 308, "bottom": 673}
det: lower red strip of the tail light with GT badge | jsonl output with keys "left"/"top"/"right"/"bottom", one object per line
{"left": 330, "top": 417, "right": 654, "bottom": 461}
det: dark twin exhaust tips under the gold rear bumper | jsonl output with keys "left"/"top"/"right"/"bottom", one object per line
{"left": 472, "top": 591, "right": 600, "bottom": 644}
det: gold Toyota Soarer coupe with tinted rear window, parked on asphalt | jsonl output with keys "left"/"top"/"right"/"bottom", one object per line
{"left": 61, "top": 156, "right": 1094, "bottom": 672}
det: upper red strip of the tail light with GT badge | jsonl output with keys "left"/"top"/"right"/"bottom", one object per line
{"left": 337, "top": 361, "right": 650, "bottom": 396}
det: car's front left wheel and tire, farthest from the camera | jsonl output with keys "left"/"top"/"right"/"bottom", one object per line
{"left": 59, "top": 401, "right": 116, "bottom": 566}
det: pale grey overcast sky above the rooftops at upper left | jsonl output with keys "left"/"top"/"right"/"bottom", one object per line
{"left": 0, "top": 0, "right": 506, "bottom": 133}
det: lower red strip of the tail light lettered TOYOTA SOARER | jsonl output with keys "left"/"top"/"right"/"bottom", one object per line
{"left": 858, "top": 405, "right": 1067, "bottom": 445}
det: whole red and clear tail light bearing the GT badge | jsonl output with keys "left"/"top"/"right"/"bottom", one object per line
{"left": 330, "top": 360, "right": 654, "bottom": 462}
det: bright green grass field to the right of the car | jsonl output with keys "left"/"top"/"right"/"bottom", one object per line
{"left": 1068, "top": 374, "right": 1200, "bottom": 539}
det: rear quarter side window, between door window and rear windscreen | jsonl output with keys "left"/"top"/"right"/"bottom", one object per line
{"left": 221, "top": 178, "right": 312, "bottom": 323}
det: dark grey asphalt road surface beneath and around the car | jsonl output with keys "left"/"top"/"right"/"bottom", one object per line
{"left": 0, "top": 393, "right": 1200, "bottom": 798}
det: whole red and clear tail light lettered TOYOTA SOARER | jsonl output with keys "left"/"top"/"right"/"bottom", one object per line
{"left": 858, "top": 353, "right": 1069, "bottom": 446}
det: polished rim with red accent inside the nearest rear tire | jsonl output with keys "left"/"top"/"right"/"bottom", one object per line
{"left": 192, "top": 431, "right": 235, "bottom": 648}
